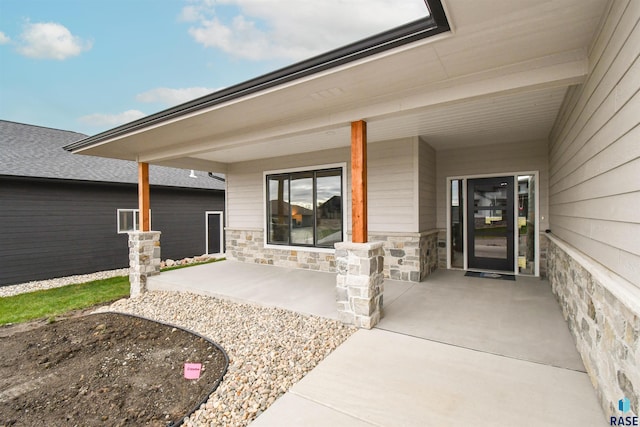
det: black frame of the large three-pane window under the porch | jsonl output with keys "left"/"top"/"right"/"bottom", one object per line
{"left": 265, "top": 166, "right": 345, "bottom": 249}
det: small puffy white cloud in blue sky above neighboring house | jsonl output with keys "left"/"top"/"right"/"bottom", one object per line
{"left": 18, "top": 22, "right": 91, "bottom": 60}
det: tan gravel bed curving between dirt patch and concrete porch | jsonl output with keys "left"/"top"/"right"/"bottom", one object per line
{"left": 98, "top": 292, "right": 356, "bottom": 426}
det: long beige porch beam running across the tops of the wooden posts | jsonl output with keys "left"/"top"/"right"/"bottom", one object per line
{"left": 140, "top": 48, "right": 587, "bottom": 166}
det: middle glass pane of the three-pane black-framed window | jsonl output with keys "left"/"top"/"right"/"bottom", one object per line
{"left": 291, "top": 173, "right": 313, "bottom": 245}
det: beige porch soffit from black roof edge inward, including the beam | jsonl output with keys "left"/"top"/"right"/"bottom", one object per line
{"left": 67, "top": 0, "right": 606, "bottom": 167}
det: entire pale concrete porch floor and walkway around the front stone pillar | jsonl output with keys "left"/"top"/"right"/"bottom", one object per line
{"left": 148, "top": 261, "right": 607, "bottom": 427}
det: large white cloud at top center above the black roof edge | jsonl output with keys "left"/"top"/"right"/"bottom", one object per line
{"left": 180, "top": 0, "right": 427, "bottom": 60}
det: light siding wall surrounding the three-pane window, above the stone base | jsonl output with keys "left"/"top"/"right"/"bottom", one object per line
{"left": 227, "top": 138, "right": 419, "bottom": 232}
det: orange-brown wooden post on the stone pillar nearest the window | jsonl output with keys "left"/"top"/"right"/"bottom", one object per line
{"left": 351, "top": 120, "right": 368, "bottom": 243}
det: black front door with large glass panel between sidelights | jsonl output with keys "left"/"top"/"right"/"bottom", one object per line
{"left": 467, "top": 176, "right": 514, "bottom": 272}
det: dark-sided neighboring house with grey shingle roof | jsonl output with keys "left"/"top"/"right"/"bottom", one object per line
{"left": 0, "top": 120, "right": 225, "bottom": 286}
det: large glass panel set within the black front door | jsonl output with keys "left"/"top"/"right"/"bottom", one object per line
{"left": 473, "top": 182, "right": 508, "bottom": 260}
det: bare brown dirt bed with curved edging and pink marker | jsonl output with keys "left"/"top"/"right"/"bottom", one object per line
{"left": 0, "top": 313, "right": 228, "bottom": 426}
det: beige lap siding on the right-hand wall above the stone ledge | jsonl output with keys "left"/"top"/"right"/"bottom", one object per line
{"left": 549, "top": 0, "right": 640, "bottom": 287}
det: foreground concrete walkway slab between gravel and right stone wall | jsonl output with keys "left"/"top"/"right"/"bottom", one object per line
{"left": 251, "top": 329, "right": 606, "bottom": 427}
